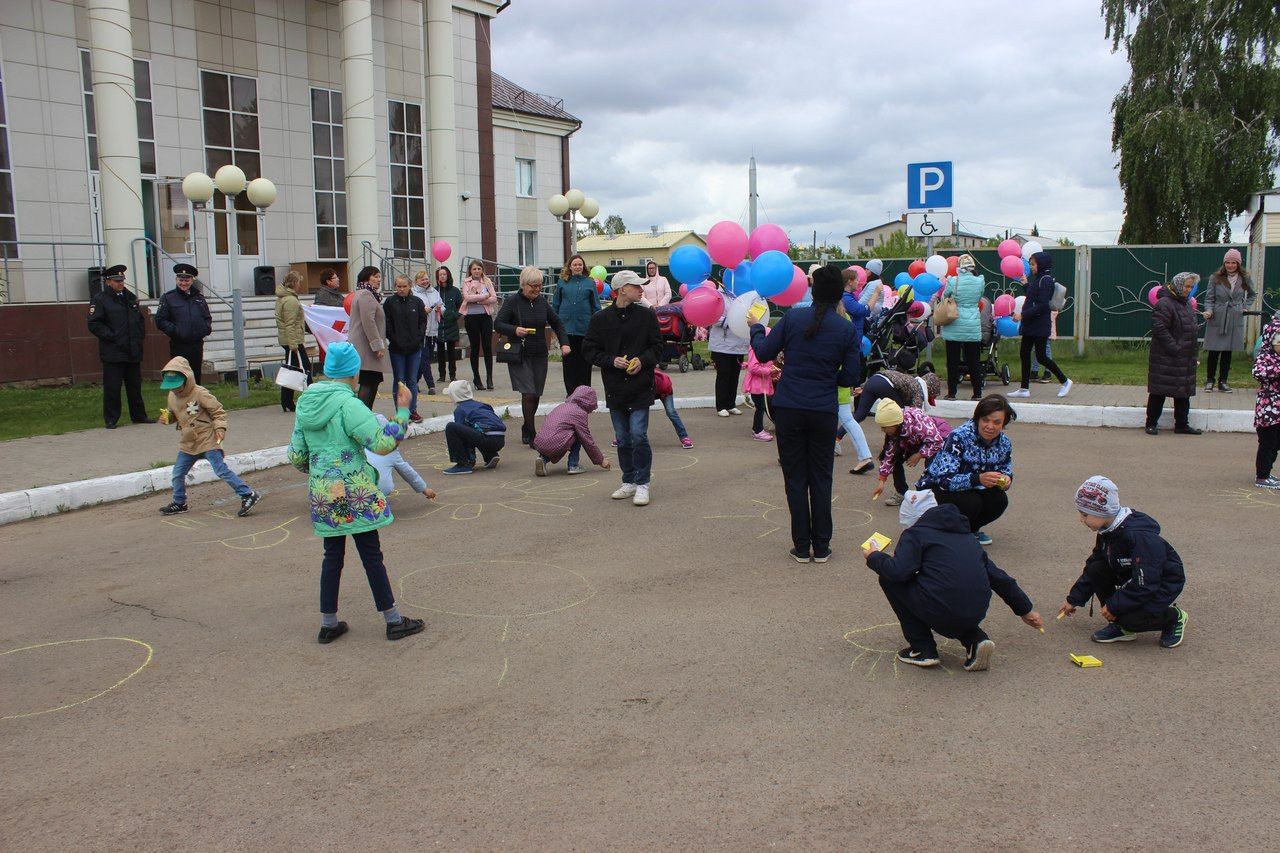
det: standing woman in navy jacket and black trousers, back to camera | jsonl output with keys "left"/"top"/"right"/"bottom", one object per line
{"left": 751, "top": 264, "right": 859, "bottom": 562}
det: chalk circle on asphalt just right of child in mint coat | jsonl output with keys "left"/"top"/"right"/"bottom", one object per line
{"left": 399, "top": 560, "right": 596, "bottom": 619}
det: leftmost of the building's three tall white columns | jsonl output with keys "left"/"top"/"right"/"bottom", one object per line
{"left": 87, "top": 0, "right": 146, "bottom": 291}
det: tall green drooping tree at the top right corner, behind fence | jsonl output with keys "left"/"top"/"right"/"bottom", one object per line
{"left": 1102, "top": 0, "right": 1280, "bottom": 243}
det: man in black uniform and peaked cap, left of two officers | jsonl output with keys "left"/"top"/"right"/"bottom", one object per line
{"left": 88, "top": 264, "right": 150, "bottom": 429}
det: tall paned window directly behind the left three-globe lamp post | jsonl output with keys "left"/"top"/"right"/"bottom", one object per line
{"left": 200, "top": 70, "right": 262, "bottom": 255}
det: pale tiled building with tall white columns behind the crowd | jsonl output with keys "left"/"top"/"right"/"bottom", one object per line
{"left": 0, "top": 0, "right": 581, "bottom": 302}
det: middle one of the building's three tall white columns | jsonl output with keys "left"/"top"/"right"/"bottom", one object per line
{"left": 342, "top": 0, "right": 381, "bottom": 266}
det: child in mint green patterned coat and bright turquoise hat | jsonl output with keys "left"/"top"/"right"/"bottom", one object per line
{"left": 289, "top": 341, "right": 424, "bottom": 643}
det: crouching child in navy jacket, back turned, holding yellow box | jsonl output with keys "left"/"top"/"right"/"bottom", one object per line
{"left": 863, "top": 503, "right": 1044, "bottom": 672}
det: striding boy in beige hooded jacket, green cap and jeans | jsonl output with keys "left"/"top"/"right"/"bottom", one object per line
{"left": 160, "top": 356, "right": 262, "bottom": 516}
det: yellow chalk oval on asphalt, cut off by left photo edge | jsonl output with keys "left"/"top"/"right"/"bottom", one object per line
{"left": 0, "top": 637, "right": 155, "bottom": 721}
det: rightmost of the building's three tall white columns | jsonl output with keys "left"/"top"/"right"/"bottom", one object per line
{"left": 424, "top": 0, "right": 462, "bottom": 264}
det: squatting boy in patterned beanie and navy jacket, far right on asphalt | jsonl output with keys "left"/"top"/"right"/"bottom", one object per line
{"left": 1059, "top": 476, "right": 1187, "bottom": 648}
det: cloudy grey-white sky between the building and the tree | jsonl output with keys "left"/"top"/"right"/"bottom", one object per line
{"left": 493, "top": 0, "right": 1244, "bottom": 246}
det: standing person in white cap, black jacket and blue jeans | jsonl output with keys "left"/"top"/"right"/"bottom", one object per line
{"left": 582, "top": 270, "right": 662, "bottom": 506}
